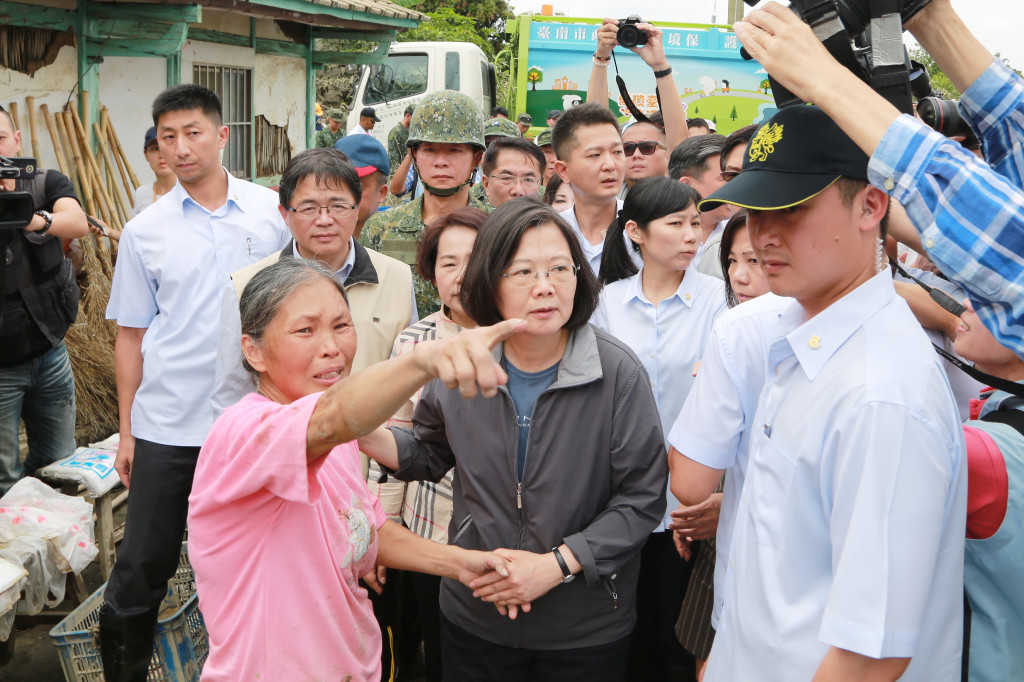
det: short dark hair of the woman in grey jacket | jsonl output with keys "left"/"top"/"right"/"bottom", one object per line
{"left": 459, "top": 196, "right": 601, "bottom": 332}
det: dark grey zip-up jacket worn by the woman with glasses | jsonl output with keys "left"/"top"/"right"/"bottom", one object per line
{"left": 392, "top": 326, "right": 668, "bottom": 649}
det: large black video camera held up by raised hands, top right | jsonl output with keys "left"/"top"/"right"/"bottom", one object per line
{"left": 742, "top": 0, "right": 931, "bottom": 114}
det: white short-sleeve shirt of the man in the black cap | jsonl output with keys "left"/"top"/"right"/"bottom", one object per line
{"left": 706, "top": 271, "right": 967, "bottom": 682}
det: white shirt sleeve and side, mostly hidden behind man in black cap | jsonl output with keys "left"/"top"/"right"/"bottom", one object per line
{"left": 669, "top": 294, "right": 793, "bottom": 629}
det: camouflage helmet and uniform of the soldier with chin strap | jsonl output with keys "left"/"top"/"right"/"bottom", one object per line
{"left": 359, "top": 90, "right": 494, "bottom": 315}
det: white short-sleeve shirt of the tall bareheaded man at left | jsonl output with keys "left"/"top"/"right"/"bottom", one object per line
{"left": 106, "top": 171, "right": 291, "bottom": 445}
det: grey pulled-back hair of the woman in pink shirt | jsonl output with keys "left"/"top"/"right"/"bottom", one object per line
{"left": 239, "top": 257, "right": 348, "bottom": 375}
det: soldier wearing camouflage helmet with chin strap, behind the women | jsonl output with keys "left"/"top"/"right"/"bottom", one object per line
{"left": 359, "top": 90, "right": 489, "bottom": 314}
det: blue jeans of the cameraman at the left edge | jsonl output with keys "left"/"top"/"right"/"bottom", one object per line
{"left": 0, "top": 342, "right": 75, "bottom": 495}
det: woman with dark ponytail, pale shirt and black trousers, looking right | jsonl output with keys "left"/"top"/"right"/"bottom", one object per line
{"left": 592, "top": 177, "right": 726, "bottom": 680}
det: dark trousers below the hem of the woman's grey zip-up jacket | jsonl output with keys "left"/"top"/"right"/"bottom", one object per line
{"left": 440, "top": 613, "right": 630, "bottom": 682}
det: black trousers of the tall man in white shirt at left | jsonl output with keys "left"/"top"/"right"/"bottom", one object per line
{"left": 103, "top": 439, "right": 200, "bottom": 622}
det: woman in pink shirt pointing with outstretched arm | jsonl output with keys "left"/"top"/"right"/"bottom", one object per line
{"left": 188, "top": 258, "right": 520, "bottom": 682}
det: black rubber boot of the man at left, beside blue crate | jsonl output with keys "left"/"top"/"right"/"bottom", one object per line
{"left": 99, "top": 604, "right": 157, "bottom": 682}
